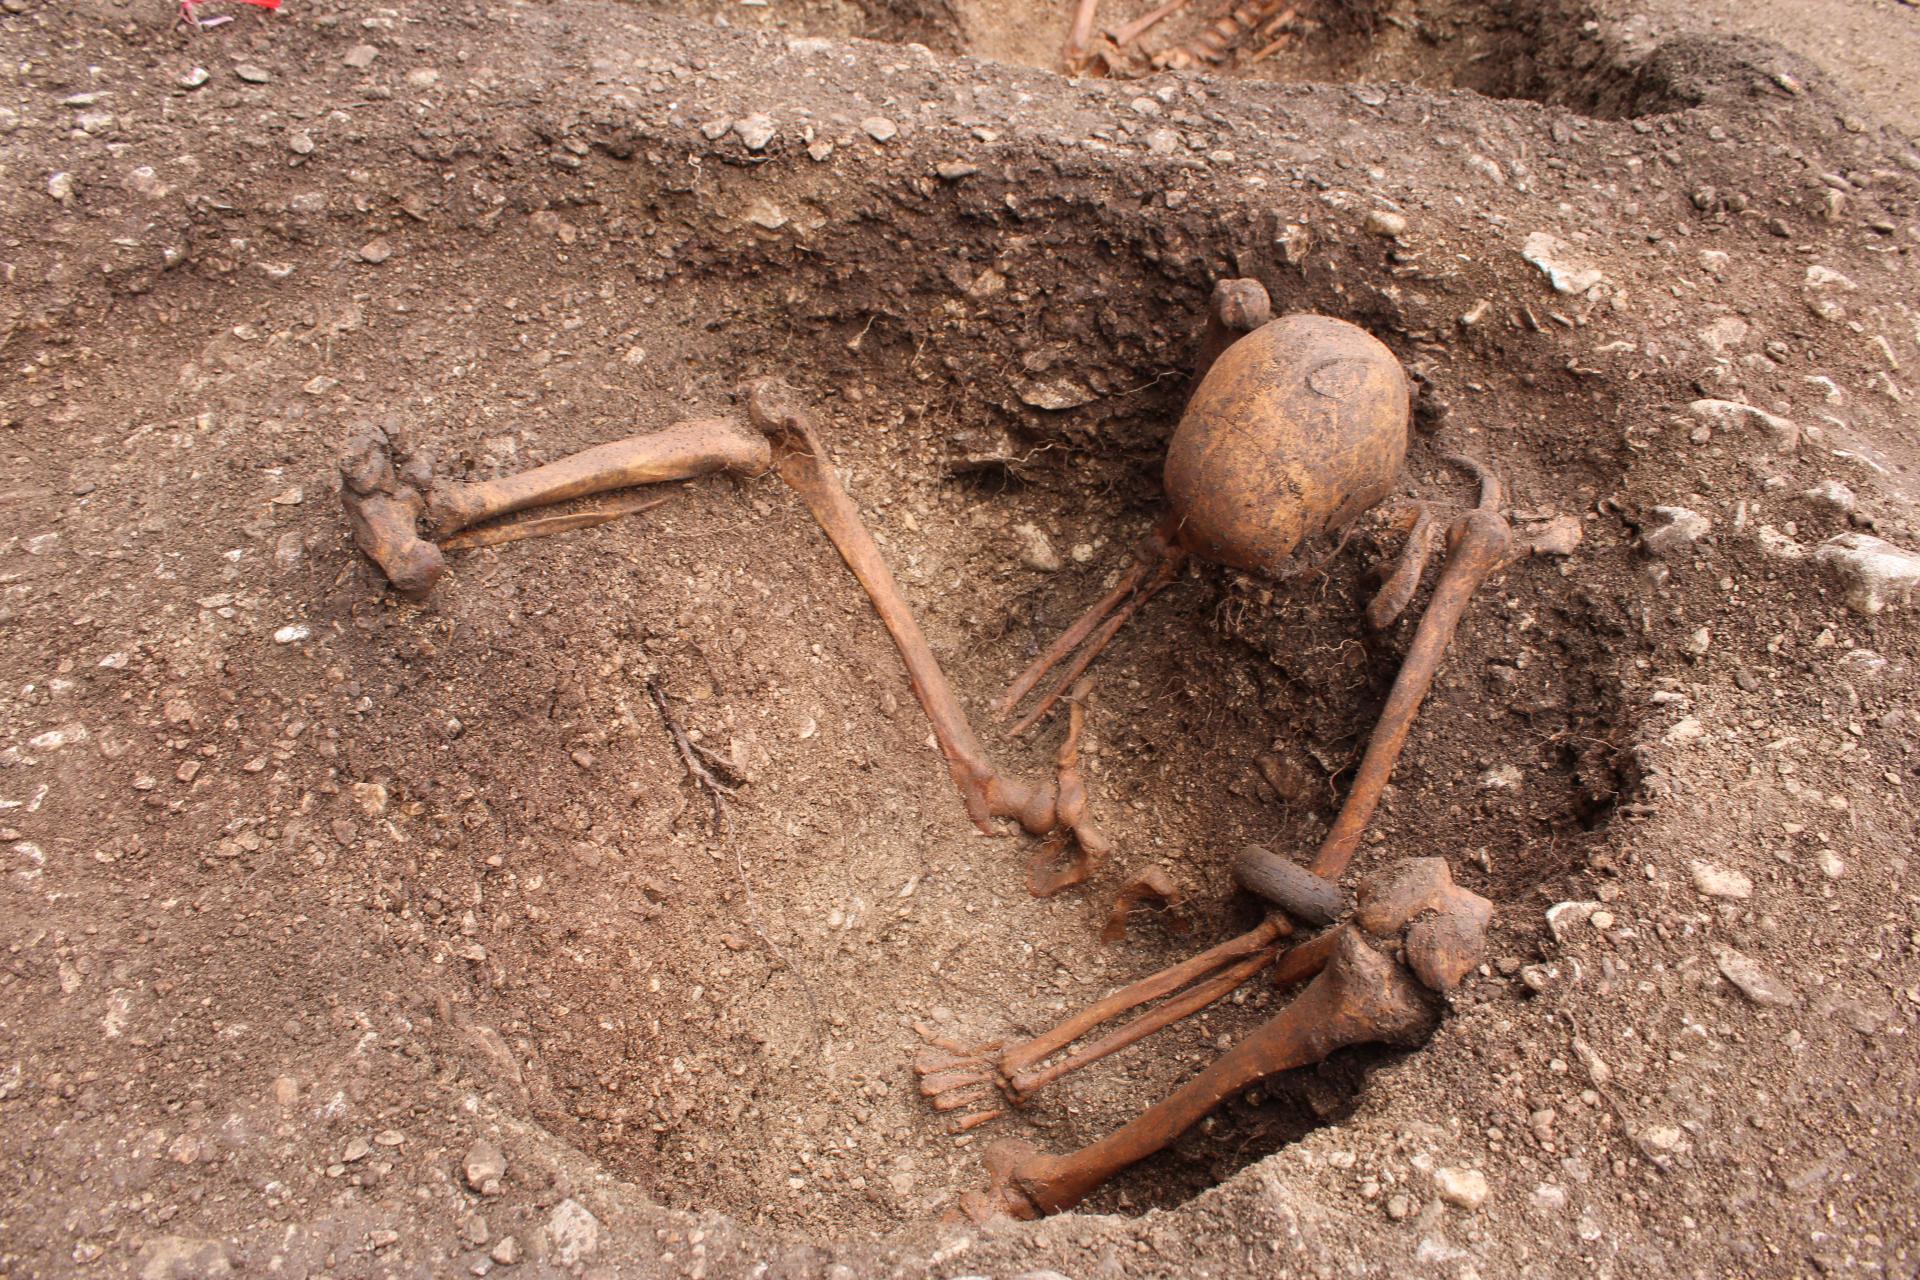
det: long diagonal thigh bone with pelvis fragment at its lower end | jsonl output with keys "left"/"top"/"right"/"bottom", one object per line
{"left": 749, "top": 380, "right": 1110, "bottom": 896}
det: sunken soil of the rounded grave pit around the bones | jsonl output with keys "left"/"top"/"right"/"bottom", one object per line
{"left": 270, "top": 84, "right": 1628, "bottom": 1232}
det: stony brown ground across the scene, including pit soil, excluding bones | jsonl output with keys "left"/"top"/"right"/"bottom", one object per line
{"left": 0, "top": 0, "right": 1920, "bottom": 1278}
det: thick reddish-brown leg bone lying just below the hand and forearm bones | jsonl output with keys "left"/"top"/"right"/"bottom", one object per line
{"left": 962, "top": 931, "right": 1434, "bottom": 1221}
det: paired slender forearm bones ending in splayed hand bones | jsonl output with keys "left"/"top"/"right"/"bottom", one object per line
{"left": 914, "top": 915, "right": 1292, "bottom": 1132}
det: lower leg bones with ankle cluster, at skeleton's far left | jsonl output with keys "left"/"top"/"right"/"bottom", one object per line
{"left": 340, "top": 418, "right": 772, "bottom": 599}
